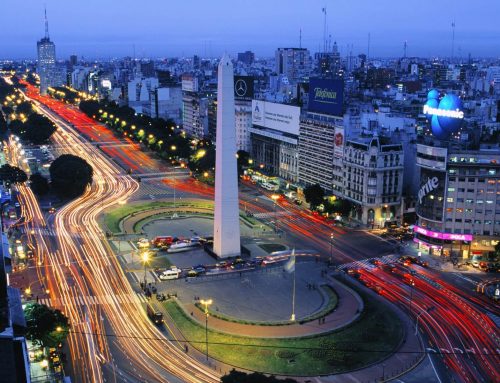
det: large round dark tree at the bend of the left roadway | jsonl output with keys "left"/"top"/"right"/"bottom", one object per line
{"left": 49, "top": 154, "right": 93, "bottom": 198}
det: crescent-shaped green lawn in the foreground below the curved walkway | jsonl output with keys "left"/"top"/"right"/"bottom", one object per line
{"left": 165, "top": 291, "right": 403, "bottom": 376}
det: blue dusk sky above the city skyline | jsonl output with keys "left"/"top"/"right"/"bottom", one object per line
{"left": 0, "top": 0, "right": 500, "bottom": 59}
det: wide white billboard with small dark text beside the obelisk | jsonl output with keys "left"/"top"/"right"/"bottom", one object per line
{"left": 252, "top": 100, "right": 300, "bottom": 136}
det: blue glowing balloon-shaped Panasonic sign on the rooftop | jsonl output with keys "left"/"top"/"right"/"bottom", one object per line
{"left": 423, "top": 89, "right": 464, "bottom": 140}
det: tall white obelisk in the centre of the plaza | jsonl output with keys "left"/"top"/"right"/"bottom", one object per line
{"left": 214, "top": 54, "right": 241, "bottom": 258}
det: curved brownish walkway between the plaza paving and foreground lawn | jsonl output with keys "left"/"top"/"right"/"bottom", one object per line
{"left": 179, "top": 278, "right": 363, "bottom": 338}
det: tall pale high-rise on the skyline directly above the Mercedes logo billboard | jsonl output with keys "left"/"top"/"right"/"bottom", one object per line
{"left": 275, "top": 48, "right": 312, "bottom": 82}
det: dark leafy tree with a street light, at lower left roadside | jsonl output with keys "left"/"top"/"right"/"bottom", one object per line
{"left": 24, "top": 303, "right": 69, "bottom": 347}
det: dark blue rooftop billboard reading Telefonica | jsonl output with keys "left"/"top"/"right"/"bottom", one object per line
{"left": 309, "top": 78, "right": 344, "bottom": 116}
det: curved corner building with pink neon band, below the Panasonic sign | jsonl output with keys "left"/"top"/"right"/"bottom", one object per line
{"left": 414, "top": 145, "right": 500, "bottom": 259}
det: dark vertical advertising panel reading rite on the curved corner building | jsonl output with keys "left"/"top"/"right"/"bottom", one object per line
{"left": 416, "top": 168, "right": 446, "bottom": 222}
